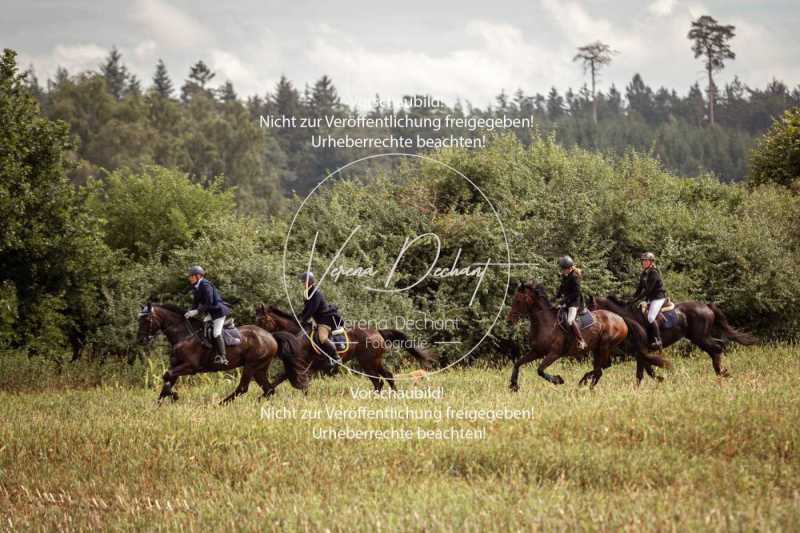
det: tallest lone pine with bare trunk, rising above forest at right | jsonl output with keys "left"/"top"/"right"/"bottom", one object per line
{"left": 687, "top": 15, "right": 736, "bottom": 125}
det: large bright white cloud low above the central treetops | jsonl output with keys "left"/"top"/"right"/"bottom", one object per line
{"left": 305, "top": 21, "right": 571, "bottom": 107}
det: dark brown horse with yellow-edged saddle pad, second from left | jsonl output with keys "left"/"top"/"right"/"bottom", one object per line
{"left": 256, "top": 304, "right": 433, "bottom": 391}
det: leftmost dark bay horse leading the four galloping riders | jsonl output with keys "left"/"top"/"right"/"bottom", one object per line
{"left": 137, "top": 303, "right": 294, "bottom": 404}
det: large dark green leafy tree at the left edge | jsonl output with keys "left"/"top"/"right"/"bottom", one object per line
{"left": 0, "top": 49, "right": 110, "bottom": 351}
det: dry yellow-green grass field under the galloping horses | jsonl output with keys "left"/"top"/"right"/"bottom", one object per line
{"left": 0, "top": 346, "right": 800, "bottom": 531}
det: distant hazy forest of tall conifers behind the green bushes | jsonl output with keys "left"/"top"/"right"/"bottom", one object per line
{"left": 27, "top": 44, "right": 800, "bottom": 200}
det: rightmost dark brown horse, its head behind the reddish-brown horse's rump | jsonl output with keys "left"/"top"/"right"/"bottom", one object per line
{"left": 588, "top": 295, "right": 758, "bottom": 377}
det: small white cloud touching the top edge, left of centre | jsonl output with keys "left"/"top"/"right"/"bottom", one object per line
{"left": 129, "top": 0, "right": 213, "bottom": 47}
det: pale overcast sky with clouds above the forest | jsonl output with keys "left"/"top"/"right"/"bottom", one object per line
{"left": 6, "top": 0, "right": 800, "bottom": 106}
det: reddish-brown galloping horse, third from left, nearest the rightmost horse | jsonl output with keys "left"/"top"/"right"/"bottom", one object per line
{"left": 508, "top": 282, "right": 670, "bottom": 391}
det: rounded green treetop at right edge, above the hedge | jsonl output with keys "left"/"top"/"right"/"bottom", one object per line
{"left": 749, "top": 107, "right": 800, "bottom": 192}
